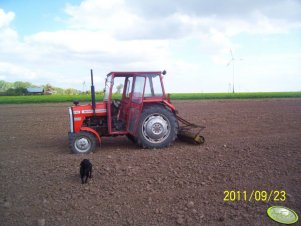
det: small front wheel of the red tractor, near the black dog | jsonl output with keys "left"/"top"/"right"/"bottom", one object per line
{"left": 69, "top": 131, "right": 96, "bottom": 154}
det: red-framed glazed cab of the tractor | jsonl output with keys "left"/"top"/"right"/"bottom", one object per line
{"left": 103, "top": 72, "right": 166, "bottom": 136}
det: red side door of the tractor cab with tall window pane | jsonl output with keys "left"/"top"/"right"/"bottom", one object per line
{"left": 127, "top": 76, "right": 145, "bottom": 136}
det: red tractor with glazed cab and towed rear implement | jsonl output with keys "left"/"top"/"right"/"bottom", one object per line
{"left": 69, "top": 70, "right": 204, "bottom": 153}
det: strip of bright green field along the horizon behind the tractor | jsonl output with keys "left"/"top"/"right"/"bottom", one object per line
{"left": 0, "top": 92, "right": 301, "bottom": 104}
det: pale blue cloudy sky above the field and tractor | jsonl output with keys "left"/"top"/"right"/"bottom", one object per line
{"left": 0, "top": 0, "right": 301, "bottom": 93}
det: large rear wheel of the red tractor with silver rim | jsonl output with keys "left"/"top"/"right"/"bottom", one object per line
{"left": 137, "top": 105, "right": 178, "bottom": 148}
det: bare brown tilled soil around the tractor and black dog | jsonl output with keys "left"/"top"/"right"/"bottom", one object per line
{"left": 0, "top": 98, "right": 301, "bottom": 226}
